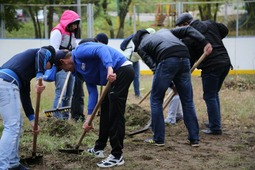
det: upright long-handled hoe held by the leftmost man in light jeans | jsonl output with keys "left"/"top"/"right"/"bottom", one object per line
{"left": 20, "top": 78, "right": 43, "bottom": 165}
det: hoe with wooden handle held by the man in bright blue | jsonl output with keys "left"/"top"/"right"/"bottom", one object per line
{"left": 59, "top": 81, "right": 111, "bottom": 154}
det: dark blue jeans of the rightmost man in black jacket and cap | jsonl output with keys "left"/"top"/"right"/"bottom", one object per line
{"left": 201, "top": 66, "right": 230, "bottom": 131}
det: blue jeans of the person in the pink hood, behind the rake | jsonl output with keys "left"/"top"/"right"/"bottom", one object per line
{"left": 53, "top": 70, "right": 74, "bottom": 119}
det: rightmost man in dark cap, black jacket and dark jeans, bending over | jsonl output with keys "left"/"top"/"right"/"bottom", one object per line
{"left": 176, "top": 13, "right": 232, "bottom": 135}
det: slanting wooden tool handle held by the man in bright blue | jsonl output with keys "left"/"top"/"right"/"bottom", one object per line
{"left": 75, "top": 81, "right": 111, "bottom": 150}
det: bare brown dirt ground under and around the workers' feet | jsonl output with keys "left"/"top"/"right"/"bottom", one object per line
{"left": 20, "top": 76, "right": 255, "bottom": 170}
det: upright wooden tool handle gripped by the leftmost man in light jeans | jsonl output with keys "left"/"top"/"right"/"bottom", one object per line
{"left": 32, "top": 78, "right": 42, "bottom": 156}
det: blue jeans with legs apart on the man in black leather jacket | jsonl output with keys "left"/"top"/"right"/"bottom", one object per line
{"left": 150, "top": 57, "right": 199, "bottom": 143}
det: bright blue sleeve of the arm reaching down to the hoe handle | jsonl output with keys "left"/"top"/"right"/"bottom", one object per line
{"left": 86, "top": 83, "right": 98, "bottom": 115}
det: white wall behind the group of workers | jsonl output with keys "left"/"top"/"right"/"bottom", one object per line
{"left": 0, "top": 37, "right": 255, "bottom": 70}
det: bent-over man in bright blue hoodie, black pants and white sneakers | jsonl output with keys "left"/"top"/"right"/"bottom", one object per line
{"left": 56, "top": 42, "right": 134, "bottom": 167}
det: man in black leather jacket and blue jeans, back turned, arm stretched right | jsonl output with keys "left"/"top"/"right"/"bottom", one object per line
{"left": 132, "top": 27, "right": 212, "bottom": 146}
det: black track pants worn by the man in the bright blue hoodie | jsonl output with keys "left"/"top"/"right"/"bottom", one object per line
{"left": 95, "top": 65, "right": 135, "bottom": 158}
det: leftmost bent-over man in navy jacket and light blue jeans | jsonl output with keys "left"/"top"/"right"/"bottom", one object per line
{"left": 0, "top": 46, "right": 55, "bottom": 170}
